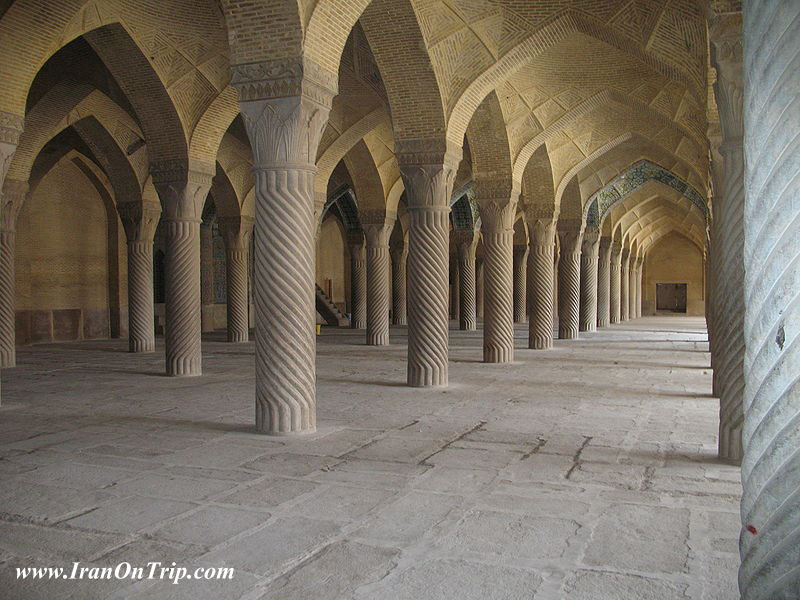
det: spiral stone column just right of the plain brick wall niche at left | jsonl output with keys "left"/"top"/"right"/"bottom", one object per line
{"left": 117, "top": 202, "right": 161, "bottom": 352}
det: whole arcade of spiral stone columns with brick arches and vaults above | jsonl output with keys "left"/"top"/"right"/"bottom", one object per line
{"left": 0, "top": 0, "right": 800, "bottom": 598}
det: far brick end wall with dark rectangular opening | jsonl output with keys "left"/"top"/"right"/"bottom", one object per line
{"left": 642, "top": 233, "right": 705, "bottom": 316}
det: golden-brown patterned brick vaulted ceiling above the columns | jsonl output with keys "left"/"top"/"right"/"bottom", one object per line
{"left": 0, "top": 0, "right": 730, "bottom": 252}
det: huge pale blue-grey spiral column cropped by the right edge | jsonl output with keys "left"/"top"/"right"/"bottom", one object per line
{"left": 740, "top": 0, "right": 800, "bottom": 600}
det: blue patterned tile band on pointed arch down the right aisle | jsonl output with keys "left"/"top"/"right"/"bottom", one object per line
{"left": 586, "top": 159, "right": 708, "bottom": 227}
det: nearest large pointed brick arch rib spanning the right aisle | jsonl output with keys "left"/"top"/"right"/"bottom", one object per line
{"left": 447, "top": 10, "right": 705, "bottom": 148}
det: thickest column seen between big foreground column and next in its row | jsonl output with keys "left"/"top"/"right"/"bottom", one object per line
{"left": 364, "top": 220, "right": 394, "bottom": 346}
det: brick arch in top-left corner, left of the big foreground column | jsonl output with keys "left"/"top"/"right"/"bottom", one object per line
{"left": 0, "top": 0, "right": 222, "bottom": 155}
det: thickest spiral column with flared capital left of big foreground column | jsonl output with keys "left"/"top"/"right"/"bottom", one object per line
{"left": 150, "top": 162, "right": 213, "bottom": 377}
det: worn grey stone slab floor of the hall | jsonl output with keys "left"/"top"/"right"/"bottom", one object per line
{"left": 0, "top": 317, "right": 740, "bottom": 600}
